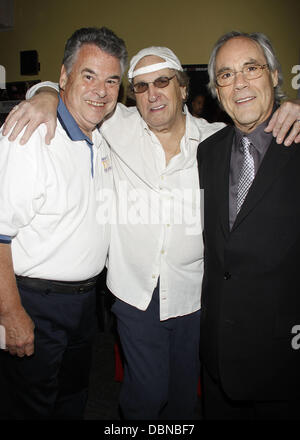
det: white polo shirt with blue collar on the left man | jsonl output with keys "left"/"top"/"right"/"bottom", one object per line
{"left": 0, "top": 98, "right": 112, "bottom": 281}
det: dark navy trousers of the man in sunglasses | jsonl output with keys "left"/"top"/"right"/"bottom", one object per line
{"left": 112, "top": 288, "right": 200, "bottom": 420}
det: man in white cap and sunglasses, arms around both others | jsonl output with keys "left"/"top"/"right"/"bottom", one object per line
{"left": 2, "top": 43, "right": 300, "bottom": 419}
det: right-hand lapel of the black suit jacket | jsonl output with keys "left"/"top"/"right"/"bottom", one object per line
{"left": 232, "top": 139, "right": 296, "bottom": 231}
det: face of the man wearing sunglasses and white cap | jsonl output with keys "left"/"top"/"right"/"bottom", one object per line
{"left": 133, "top": 55, "right": 186, "bottom": 132}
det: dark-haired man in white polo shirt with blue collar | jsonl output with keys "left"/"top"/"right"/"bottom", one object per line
{"left": 0, "top": 28, "right": 127, "bottom": 419}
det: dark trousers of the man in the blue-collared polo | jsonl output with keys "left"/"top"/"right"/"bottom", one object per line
{"left": 0, "top": 288, "right": 96, "bottom": 420}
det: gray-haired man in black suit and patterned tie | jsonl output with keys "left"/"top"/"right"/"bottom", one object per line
{"left": 198, "top": 32, "right": 300, "bottom": 419}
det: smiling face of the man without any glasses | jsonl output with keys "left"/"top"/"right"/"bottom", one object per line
{"left": 59, "top": 44, "right": 121, "bottom": 138}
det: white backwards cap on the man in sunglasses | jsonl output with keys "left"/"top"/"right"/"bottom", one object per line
{"left": 128, "top": 46, "right": 183, "bottom": 79}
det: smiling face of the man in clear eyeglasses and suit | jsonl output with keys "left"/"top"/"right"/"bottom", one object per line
{"left": 216, "top": 37, "right": 278, "bottom": 133}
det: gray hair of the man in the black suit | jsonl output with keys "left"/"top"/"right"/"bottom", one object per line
{"left": 208, "top": 31, "right": 285, "bottom": 103}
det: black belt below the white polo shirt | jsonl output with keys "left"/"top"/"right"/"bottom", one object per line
{"left": 16, "top": 275, "right": 98, "bottom": 294}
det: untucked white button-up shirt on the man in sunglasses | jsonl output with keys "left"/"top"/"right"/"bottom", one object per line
{"left": 29, "top": 83, "right": 224, "bottom": 320}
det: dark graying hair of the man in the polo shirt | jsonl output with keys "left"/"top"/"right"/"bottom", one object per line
{"left": 63, "top": 27, "right": 128, "bottom": 75}
